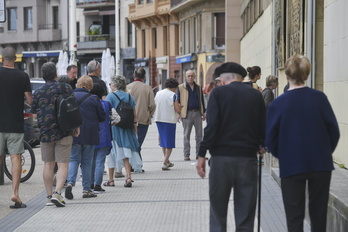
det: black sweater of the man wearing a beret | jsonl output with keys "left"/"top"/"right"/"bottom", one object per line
{"left": 198, "top": 82, "right": 266, "bottom": 160}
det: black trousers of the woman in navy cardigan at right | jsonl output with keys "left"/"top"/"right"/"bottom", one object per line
{"left": 281, "top": 171, "right": 332, "bottom": 232}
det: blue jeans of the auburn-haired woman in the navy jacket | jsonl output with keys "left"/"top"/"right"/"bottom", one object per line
{"left": 68, "top": 144, "right": 95, "bottom": 191}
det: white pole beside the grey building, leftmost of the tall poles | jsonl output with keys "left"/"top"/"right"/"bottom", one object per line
{"left": 69, "top": 0, "right": 77, "bottom": 65}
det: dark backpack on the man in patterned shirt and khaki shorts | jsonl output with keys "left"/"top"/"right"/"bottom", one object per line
{"left": 55, "top": 89, "right": 91, "bottom": 133}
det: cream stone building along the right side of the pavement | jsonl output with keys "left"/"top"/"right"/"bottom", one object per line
{"left": 239, "top": 0, "right": 348, "bottom": 231}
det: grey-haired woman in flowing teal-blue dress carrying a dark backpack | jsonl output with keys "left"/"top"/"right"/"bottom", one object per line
{"left": 104, "top": 75, "right": 142, "bottom": 187}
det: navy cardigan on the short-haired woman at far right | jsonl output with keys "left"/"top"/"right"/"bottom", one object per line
{"left": 266, "top": 87, "right": 340, "bottom": 178}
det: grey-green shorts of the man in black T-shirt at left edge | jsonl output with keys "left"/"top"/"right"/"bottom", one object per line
{"left": 0, "top": 132, "right": 24, "bottom": 156}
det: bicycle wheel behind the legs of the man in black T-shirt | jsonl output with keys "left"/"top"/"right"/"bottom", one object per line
{"left": 4, "top": 141, "right": 35, "bottom": 183}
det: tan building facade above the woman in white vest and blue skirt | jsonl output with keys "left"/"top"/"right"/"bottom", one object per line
{"left": 129, "top": 0, "right": 182, "bottom": 89}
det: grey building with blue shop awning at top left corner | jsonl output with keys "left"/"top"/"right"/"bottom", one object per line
{"left": 0, "top": 0, "right": 68, "bottom": 77}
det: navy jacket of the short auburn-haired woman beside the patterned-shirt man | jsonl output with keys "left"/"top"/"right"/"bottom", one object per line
{"left": 73, "top": 88, "right": 105, "bottom": 145}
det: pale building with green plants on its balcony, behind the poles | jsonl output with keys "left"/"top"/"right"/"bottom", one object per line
{"left": 76, "top": 0, "right": 135, "bottom": 82}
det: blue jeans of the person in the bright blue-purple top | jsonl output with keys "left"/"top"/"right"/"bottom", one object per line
{"left": 91, "top": 147, "right": 110, "bottom": 185}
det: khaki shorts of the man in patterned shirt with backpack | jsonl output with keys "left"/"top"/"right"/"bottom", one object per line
{"left": 40, "top": 136, "right": 73, "bottom": 163}
